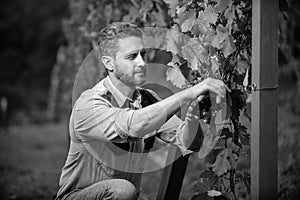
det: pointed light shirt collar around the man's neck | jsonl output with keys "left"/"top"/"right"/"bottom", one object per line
{"left": 104, "top": 76, "right": 141, "bottom": 108}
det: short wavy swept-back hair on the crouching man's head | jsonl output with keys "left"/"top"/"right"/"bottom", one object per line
{"left": 97, "top": 22, "right": 143, "bottom": 57}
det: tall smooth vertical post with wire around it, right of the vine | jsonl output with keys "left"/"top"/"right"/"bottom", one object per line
{"left": 251, "top": 0, "right": 278, "bottom": 200}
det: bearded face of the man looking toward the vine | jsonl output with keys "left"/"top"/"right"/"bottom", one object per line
{"left": 113, "top": 36, "right": 146, "bottom": 86}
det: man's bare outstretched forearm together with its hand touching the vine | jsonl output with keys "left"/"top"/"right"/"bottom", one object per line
{"left": 129, "top": 78, "right": 230, "bottom": 137}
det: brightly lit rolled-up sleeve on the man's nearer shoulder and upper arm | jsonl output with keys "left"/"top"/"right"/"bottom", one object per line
{"left": 72, "top": 92, "right": 133, "bottom": 142}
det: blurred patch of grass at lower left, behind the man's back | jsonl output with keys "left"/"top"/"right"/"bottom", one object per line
{"left": 0, "top": 124, "right": 68, "bottom": 200}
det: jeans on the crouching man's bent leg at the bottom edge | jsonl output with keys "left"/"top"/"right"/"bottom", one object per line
{"left": 63, "top": 179, "right": 138, "bottom": 200}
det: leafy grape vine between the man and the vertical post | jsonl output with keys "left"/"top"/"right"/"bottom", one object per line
{"left": 164, "top": 0, "right": 252, "bottom": 199}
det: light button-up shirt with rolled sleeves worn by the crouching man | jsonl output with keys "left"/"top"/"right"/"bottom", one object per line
{"left": 57, "top": 77, "right": 191, "bottom": 199}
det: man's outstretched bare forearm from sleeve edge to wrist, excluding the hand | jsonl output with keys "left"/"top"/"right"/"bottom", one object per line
{"left": 129, "top": 88, "right": 194, "bottom": 137}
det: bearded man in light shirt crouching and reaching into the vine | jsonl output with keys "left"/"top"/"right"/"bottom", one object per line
{"left": 57, "top": 22, "right": 227, "bottom": 200}
